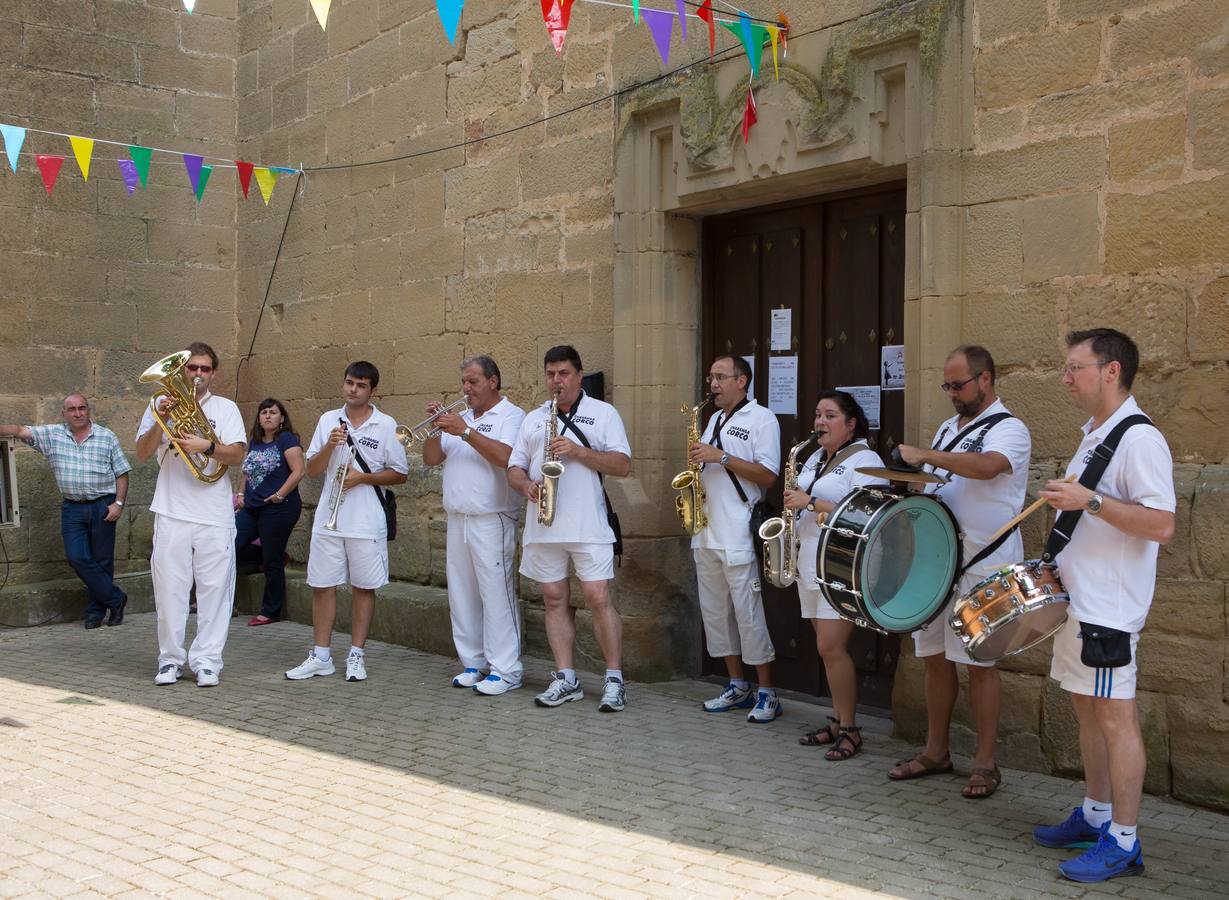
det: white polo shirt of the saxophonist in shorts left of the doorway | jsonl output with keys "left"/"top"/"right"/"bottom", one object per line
{"left": 508, "top": 393, "right": 632, "bottom": 546}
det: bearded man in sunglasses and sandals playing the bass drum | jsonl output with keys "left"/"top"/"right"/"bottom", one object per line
{"left": 887, "top": 344, "right": 1032, "bottom": 799}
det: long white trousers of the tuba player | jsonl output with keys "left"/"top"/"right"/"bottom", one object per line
{"left": 150, "top": 515, "right": 235, "bottom": 671}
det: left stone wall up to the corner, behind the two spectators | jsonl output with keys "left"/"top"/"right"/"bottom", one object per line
{"left": 0, "top": 0, "right": 241, "bottom": 583}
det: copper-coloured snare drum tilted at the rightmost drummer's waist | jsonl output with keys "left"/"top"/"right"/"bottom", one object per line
{"left": 950, "top": 559, "right": 1068, "bottom": 663}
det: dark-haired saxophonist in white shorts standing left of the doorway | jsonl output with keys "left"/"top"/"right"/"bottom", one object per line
{"left": 508, "top": 347, "right": 632, "bottom": 712}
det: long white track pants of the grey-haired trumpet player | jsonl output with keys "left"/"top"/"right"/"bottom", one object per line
{"left": 447, "top": 513, "right": 521, "bottom": 680}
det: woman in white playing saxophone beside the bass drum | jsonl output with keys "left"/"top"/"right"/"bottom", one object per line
{"left": 784, "top": 391, "right": 887, "bottom": 761}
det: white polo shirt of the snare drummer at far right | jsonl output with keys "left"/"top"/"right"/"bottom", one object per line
{"left": 1056, "top": 397, "right": 1177, "bottom": 632}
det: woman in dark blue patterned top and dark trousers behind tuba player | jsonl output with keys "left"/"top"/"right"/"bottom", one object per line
{"left": 235, "top": 397, "right": 307, "bottom": 625}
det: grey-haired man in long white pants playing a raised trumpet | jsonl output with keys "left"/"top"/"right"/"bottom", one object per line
{"left": 423, "top": 357, "right": 525, "bottom": 696}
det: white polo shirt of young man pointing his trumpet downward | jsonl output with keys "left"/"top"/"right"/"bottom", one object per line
{"left": 307, "top": 403, "right": 409, "bottom": 539}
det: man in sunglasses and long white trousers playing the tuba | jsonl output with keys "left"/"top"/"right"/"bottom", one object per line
{"left": 136, "top": 343, "right": 247, "bottom": 687}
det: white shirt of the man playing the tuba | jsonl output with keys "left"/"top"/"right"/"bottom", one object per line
{"left": 136, "top": 393, "right": 247, "bottom": 530}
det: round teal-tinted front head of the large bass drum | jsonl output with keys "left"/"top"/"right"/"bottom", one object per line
{"left": 858, "top": 494, "right": 961, "bottom": 633}
